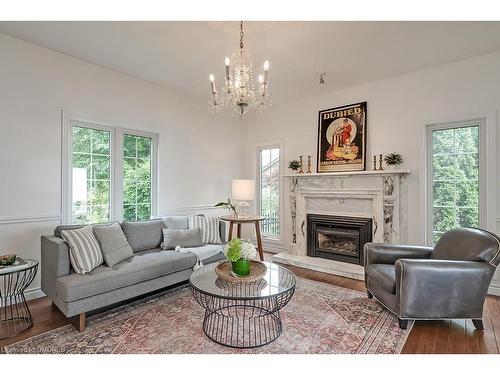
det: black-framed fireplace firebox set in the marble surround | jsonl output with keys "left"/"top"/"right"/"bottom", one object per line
{"left": 307, "top": 215, "right": 372, "bottom": 265}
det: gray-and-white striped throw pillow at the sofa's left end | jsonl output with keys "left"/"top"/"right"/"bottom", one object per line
{"left": 61, "top": 226, "right": 103, "bottom": 275}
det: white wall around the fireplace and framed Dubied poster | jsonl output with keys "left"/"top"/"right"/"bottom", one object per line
{"left": 243, "top": 53, "right": 500, "bottom": 292}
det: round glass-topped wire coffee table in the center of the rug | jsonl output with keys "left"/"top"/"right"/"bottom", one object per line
{"left": 189, "top": 262, "right": 295, "bottom": 348}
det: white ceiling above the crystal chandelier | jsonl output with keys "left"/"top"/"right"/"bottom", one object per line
{"left": 0, "top": 22, "right": 500, "bottom": 103}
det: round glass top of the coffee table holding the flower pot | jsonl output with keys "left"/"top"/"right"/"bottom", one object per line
{"left": 189, "top": 262, "right": 295, "bottom": 299}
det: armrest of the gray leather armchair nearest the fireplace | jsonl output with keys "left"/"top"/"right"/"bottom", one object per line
{"left": 364, "top": 242, "right": 433, "bottom": 266}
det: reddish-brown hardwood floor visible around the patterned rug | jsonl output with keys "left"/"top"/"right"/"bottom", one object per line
{"left": 0, "top": 253, "right": 500, "bottom": 354}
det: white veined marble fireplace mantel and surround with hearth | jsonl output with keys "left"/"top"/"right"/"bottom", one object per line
{"left": 274, "top": 170, "right": 410, "bottom": 279}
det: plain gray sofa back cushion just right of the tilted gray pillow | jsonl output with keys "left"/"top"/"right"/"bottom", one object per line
{"left": 121, "top": 219, "right": 164, "bottom": 252}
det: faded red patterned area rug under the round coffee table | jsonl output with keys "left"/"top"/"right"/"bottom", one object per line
{"left": 6, "top": 278, "right": 411, "bottom": 354}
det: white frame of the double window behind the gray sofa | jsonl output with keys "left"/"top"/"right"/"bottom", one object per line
{"left": 61, "top": 110, "right": 159, "bottom": 224}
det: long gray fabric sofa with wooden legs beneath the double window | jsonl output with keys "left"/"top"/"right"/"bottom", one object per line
{"left": 41, "top": 217, "right": 225, "bottom": 331}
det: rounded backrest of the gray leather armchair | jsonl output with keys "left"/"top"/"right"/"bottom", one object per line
{"left": 431, "top": 228, "right": 500, "bottom": 266}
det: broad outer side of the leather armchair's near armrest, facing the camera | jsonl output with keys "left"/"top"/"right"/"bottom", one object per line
{"left": 395, "top": 259, "right": 495, "bottom": 319}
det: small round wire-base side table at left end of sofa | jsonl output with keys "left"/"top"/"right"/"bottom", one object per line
{"left": 0, "top": 259, "right": 38, "bottom": 339}
